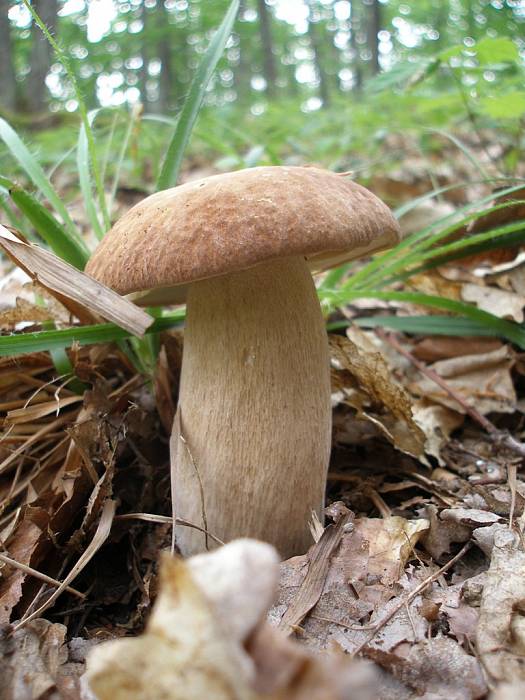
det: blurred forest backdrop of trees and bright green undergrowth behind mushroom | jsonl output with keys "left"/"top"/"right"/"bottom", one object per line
{"left": 0, "top": 0, "right": 525, "bottom": 179}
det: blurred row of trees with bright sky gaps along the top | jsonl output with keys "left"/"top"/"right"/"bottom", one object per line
{"left": 0, "top": 0, "right": 525, "bottom": 115}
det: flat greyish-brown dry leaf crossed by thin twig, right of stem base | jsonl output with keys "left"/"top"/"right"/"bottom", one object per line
{"left": 270, "top": 517, "right": 428, "bottom": 652}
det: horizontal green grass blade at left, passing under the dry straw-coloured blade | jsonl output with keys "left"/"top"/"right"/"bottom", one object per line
{"left": 0, "top": 309, "right": 185, "bottom": 357}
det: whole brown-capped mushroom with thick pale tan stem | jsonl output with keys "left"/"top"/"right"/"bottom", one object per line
{"left": 86, "top": 166, "right": 399, "bottom": 557}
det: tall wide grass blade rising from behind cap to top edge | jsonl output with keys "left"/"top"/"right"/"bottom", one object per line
{"left": 157, "top": 0, "right": 240, "bottom": 190}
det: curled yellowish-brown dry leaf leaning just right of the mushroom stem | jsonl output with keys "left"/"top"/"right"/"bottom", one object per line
{"left": 330, "top": 335, "right": 425, "bottom": 456}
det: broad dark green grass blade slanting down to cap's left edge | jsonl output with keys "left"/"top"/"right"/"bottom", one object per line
{"left": 0, "top": 177, "right": 89, "bottom": 270}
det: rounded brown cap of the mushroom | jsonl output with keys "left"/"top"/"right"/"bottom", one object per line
{"left": 86, "top": 166, "right": 400, "bottom": 304}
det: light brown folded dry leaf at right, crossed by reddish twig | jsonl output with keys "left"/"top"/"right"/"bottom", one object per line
{"left": 409, "top": 346, "right": 517, "bottom": 415}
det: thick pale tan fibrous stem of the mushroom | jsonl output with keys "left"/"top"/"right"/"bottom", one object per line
{"left": 171, "top": 257, "right": 331, "bottom": 557}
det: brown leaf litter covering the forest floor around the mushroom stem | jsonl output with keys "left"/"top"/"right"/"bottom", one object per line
{"left": 0, "top": 144, "right": 525, "bottom": 700}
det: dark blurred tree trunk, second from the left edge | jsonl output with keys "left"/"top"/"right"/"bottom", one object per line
{"left": 27, "top": 0, "right": 58, "bottom": 112}
